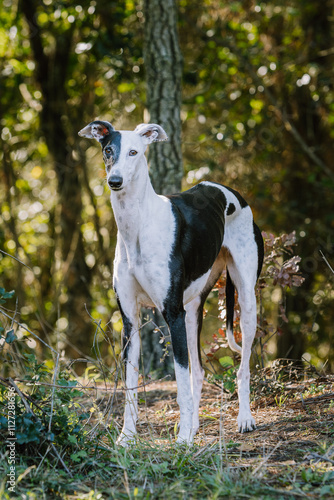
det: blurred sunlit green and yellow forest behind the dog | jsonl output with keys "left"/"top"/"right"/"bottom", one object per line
{"left": 0, "top": 0, "right": 334, "bottom": 371}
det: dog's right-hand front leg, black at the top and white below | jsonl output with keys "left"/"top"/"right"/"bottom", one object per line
{"left": 164, "top": 308, "right": 194, "bottom": 444}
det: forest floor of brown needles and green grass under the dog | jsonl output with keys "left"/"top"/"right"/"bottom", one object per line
{"left": 0, "top": 366, "right": 334, "bottom": 500}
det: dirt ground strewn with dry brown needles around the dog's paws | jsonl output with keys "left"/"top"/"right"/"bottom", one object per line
{"left": 110, "top": 366, "right": 334, "bottom": 467}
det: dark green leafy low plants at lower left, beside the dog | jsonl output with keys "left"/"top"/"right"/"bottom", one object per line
{"left": 0, "top": 353, "right": 90, "bottom": 463}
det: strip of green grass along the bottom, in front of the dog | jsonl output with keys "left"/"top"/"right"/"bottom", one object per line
{"left": 1, "top": 434, "right": 334, "bottom": 499}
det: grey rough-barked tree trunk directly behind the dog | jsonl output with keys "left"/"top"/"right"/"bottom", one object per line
{"left": 142, "top": 0, "right": 183, "bottom": 376}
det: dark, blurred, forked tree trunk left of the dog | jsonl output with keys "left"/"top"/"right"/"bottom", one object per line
{"left": 21, "top": 0, "right": 93, "bottom": 358}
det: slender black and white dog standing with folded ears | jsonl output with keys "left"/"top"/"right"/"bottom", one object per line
{"left": 79, "top": 121, "right": 263, "bottom": 445}
